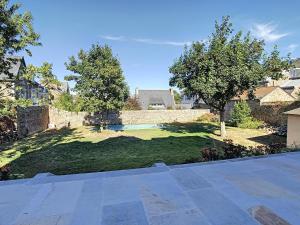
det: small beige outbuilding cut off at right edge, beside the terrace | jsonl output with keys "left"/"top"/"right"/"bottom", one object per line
{"left": 285, "top": 108, "right": 300, "bottom": 148}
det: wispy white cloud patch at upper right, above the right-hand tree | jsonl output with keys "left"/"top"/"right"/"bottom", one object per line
{"left": 252, "top": 23, "right": 289, "bottom": 42}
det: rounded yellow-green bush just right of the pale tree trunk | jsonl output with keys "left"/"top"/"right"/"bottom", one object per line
{"left": 230, "top": 101, "right": 263, "bottom": 129}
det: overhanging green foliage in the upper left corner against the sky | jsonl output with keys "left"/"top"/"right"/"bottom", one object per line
{"left": 0, "top": 0, "right": 41, "bottom": 75}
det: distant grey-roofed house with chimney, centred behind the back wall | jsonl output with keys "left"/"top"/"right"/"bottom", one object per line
{"left": 135, "top": 89, "right": 176, "bottom": 110}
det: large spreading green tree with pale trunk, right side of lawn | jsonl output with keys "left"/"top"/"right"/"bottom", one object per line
{"left": 170, "top": 16, "right": 291, "bottom": 137}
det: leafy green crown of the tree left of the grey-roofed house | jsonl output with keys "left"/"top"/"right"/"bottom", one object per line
{"left": 65, "top": 44, "right": 129, "bottom": 115}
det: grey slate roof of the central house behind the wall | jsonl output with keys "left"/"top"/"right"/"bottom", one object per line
{"left": 137, "top": 90, "right": 175, "bottom": 109}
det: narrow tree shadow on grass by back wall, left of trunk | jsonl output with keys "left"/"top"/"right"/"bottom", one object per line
{"left": 161, "top": 122, "right": 219, "bottom": 133}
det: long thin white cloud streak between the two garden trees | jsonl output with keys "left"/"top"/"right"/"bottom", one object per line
{"left": 100, "top": 35, "right": 192, "bottom": 46}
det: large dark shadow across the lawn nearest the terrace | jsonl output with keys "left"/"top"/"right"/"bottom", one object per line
{"left": 10, "top": 129, "right": 221, "bottom": 178}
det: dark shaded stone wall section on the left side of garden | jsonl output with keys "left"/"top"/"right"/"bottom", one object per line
{"left": 17, "top": 106, "right": 49, "bottom": 137}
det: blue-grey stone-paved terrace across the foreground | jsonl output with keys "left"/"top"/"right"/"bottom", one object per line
{"left": 0, "top": 153, "right": 300, "bottom": 225}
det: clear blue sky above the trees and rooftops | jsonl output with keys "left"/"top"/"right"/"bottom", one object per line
{"left": 17, "top": 0, "right": 300, "bottom": 92}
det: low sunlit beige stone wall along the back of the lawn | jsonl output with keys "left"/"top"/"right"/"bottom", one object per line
{"left": 49, "top": 108, "right": 209, "bottom": 128}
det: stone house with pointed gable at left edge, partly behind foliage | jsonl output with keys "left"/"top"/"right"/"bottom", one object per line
{"left": 0, "top": 56, "right": 48, "bottom": 105}
